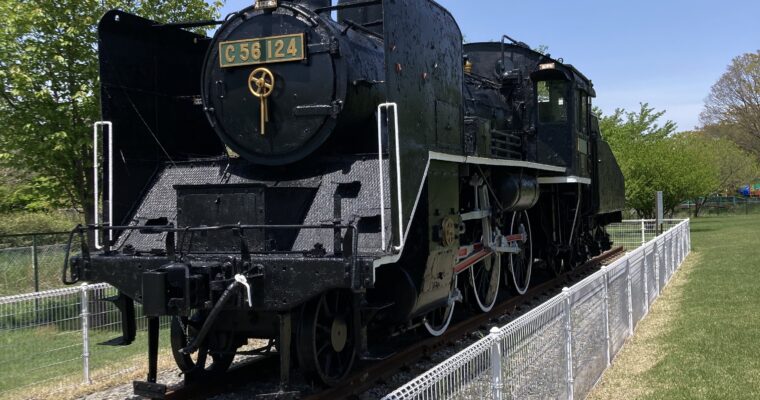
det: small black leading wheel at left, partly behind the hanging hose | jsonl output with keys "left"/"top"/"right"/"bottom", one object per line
{"left": 169, "top": 314, "right": 236, "bottom": 379}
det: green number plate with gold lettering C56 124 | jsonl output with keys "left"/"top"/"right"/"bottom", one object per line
{"left": 219, "top": 33, "right": 306, "bottom": 68}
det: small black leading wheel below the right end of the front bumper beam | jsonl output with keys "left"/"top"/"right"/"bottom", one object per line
{"left": 297, "top": 290, "right": 356, "bottom": 386}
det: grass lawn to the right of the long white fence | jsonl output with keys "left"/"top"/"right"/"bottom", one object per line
{"left": 589, "top": 214, "right": 760, "bottom": 399}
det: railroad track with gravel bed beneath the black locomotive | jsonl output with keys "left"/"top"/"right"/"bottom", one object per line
{"left": 160, "top": 247, "right": 624, "bottom": 400}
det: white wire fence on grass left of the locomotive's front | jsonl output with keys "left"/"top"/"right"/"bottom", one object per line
{"left": 0, "top": 283, "right": 168, "bottom": 398}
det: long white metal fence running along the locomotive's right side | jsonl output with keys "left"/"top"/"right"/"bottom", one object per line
{"left": 384, "top": 220, "right": 691, "bottom": 400}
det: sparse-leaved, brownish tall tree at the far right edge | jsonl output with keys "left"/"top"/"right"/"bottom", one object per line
{"left": 700, "top": 50, "right": 760, "bottom": 155}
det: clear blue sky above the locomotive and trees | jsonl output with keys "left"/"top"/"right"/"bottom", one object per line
{"left": 212, "top": 0, "right": 760, "bottom": 130}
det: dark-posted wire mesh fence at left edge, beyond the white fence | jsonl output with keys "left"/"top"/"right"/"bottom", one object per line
{"left": 0, "top": 232, "right": 69, "bottom": 296}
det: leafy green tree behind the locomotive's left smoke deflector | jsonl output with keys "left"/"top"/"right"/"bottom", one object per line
{"left": 0, "top": 0, "right": 222, "bottom": 227}
